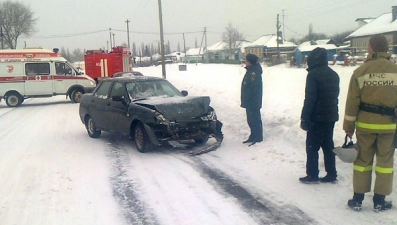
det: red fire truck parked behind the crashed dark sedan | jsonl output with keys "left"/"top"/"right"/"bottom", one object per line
{"left": 84, "top": 46, "right": 132, "bottom": 83}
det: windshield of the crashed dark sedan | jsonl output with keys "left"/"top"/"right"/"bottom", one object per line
{"left": 126, "top": 80, "right": 182, "bottom": 100}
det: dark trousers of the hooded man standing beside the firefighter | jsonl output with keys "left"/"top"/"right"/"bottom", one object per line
{"left": 306, "top": 122, "right": 337, "bottom": 178}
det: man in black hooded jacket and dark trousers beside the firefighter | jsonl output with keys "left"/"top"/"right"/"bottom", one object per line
{"left": 299, "top": 48, "right": 339, "bottom": 183}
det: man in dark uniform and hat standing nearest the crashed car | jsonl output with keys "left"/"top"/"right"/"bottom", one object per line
{"left": 241, "top": 54, "right": 263, "bottom": 146}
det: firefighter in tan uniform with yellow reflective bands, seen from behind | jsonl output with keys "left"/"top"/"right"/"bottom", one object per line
{"left": 343, "top": 35, "right": 397, "bottom": 212}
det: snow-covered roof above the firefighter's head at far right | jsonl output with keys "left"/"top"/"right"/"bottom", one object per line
{"left": 347, "top": 13, "right": 397, "bottom": 38}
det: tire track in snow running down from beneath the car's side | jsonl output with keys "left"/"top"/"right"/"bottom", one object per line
{"left": 109, "top": 136, "right": 160, "bottom": 225}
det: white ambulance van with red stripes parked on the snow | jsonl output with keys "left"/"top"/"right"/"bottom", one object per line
{"left": 0, "top": 48, "right": 96, "bottom": 107}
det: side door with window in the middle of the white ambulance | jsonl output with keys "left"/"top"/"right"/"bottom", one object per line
{"left": 25, "top": 62, "right": 54, "bottom": 96}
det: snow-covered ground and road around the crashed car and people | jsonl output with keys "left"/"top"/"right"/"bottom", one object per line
{"left": 0, "top": 64, "right": 397, "bottom": 225}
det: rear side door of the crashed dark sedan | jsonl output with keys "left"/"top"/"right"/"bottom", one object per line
{"left": 89, "top": 81, "right": 113, "bottom": 130}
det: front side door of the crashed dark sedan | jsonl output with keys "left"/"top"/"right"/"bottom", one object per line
{"left": 107, "top": 81, "right": 130, "bottom": 134}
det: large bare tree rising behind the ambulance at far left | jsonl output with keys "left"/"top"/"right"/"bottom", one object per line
{"left": 0, "top": 1, "right": 37, "bottom": 49}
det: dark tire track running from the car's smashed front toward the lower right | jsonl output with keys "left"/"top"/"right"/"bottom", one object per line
{"left": 193, "top": 158, "right": 317, "bottom": 225}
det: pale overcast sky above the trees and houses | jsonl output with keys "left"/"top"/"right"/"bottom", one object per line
{"left": 17, "top": 0, "right": 397, "bottom": 51}
